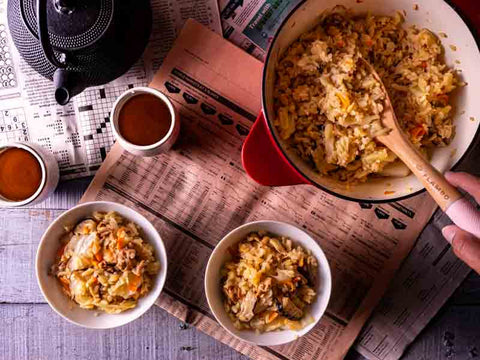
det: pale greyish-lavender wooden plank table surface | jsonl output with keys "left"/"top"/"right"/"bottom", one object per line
{"left": 0, "top": 179, "right": 480, "bottom": 360}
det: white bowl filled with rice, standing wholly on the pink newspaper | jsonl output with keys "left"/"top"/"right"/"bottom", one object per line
{"left": 205, "top": 221, "right": 331, "bottom": 346}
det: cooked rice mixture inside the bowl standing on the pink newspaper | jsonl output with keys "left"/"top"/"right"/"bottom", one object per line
{"left": 222, "top": 232, "right": 318, "bottom": 332}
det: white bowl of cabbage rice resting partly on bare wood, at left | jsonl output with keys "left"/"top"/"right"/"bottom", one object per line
{"left": 36, "top": 201, "right": 167, "bottom": 329}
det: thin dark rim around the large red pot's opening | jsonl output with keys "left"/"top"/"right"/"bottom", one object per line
{"left": 262, "top": 0, "right": 480, "bottom": 204}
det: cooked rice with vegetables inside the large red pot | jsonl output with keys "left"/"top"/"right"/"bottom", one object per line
{"left": 274, "top": 7, "right": 463, "bottom": 182}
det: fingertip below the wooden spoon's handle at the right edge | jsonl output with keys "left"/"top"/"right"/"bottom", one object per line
{"left": 442, "top": 225, "right": 480, "bottom": 274}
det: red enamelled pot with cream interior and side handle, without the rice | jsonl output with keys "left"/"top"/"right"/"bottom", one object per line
{"left": 242, "top": 0, "right": 480, "bottom": 202}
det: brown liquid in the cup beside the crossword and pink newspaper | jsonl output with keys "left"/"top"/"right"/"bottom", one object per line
{"left": 118, "top": 94, "right": 172, "bottom": 146}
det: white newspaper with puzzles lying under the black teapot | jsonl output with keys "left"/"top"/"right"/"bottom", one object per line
{"left": 0, "top": 0, "right": 221, "bottom": 179}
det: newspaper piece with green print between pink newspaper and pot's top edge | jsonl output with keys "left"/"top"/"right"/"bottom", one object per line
{"left": 218, "top": 0, "right": 301, "bottom": 61}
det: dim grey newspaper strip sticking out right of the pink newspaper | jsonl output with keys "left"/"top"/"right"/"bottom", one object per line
{"left": 355, "top": 210, "right": 471, "bottom": 360}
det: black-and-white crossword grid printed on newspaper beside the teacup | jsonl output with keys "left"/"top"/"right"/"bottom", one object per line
{"left": 77, "top": 84, "right": 136, "bottom": 170}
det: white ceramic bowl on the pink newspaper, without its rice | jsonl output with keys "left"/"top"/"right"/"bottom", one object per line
{"left": 205, "top": 221, "right": 332, "bottom": 346}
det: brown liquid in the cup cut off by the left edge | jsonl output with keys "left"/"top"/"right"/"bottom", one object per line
{"left": 0, "top": 148, "right": 42, "bottom": 201}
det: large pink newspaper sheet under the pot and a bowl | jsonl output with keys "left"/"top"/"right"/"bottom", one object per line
{"left": 82, "top": 20, "right": 446, "bottom": 360}
